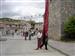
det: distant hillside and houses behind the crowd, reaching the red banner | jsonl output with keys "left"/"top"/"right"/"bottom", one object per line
{"left": 0, "top": 18, "right": 43, "bottom": 35}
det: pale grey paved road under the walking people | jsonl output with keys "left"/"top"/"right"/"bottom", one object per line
{"left": 0, "top": 36, "right": 65, "bottom": 56}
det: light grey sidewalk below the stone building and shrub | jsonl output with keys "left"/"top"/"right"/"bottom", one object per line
{"left": 48, "top": 40, "right": 75, "bottom": 56}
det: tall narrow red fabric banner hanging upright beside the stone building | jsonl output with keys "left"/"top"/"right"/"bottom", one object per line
{"left": 43, "top": 0, "right": 49, "bottom": 35}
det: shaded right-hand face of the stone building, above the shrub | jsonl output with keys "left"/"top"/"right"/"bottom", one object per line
{"left": 60, "top": 0, "right": 75, "bottom": 34}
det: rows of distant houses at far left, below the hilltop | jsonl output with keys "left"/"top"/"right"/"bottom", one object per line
{"left": 0, "top": 20, "right": 31, "bottom": 35}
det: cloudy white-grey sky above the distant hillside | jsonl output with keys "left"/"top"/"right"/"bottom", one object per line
{"left": 0, "top": 0, "right": 45, "bottom": 22}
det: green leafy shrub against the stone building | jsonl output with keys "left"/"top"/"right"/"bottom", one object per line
{"left": 64, "top": 16, "right": 75, "bottom": 39}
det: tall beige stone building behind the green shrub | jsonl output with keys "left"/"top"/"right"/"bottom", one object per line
{"left": 49, "top": 0, "right": 75, "bottom": 40}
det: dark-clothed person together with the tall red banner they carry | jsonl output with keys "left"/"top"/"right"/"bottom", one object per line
{"left": 40, "top": 0, "right": 49, "bottom": 50}
